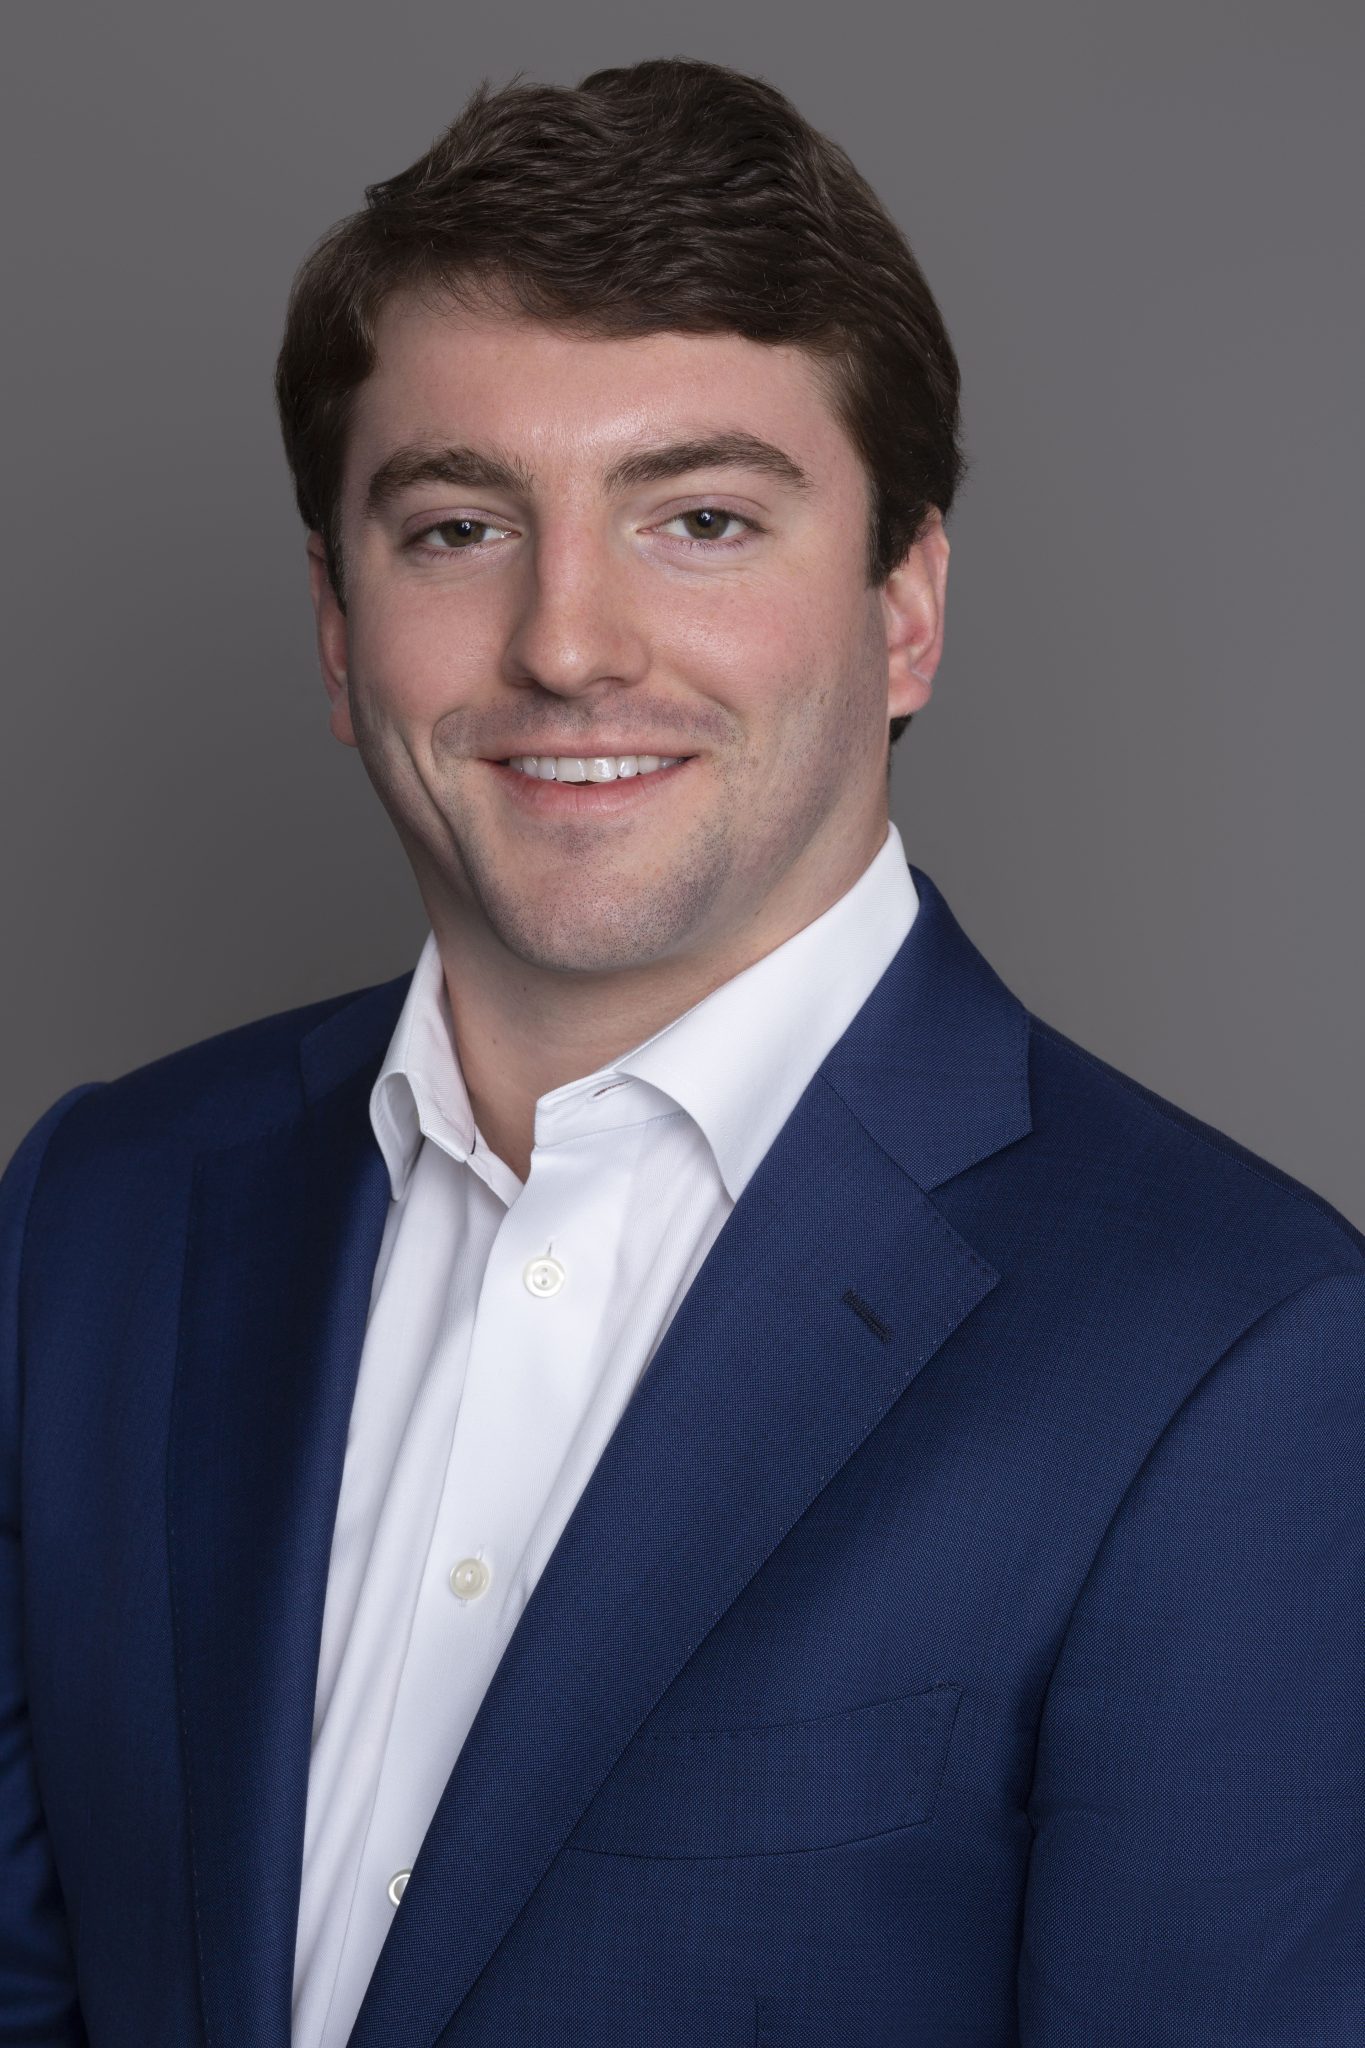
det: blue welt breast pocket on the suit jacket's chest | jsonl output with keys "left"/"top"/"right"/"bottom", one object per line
{"left": 569, "top": 1686, "right": 962, "bottom": 1855}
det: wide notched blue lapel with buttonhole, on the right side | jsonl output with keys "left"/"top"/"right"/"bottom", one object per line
{"left": 352, "top": 870, "right": 1029, "bottom": 2048}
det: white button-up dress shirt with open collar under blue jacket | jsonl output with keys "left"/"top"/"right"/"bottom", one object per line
{"left": 293, "top": 825, "right": 919, "bottom": 2048}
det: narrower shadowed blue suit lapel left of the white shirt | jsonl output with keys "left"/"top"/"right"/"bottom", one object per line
{"left": 168, "top": 977, "right": 407, "bottom": 2048}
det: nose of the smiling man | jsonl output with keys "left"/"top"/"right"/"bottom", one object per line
{"left": 503, "top": 522, "right": 649, "bottom": 696}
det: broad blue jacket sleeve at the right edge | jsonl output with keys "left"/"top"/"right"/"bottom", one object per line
{"left": 1019, "top": 1272, "right": 1365, "bottom": 2048}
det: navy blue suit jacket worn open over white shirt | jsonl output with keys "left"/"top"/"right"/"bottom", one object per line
{"left": 0, "top": 868, "right": 1365, "bottom": 2048}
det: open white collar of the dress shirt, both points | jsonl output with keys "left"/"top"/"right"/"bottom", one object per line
{"left": 370, "top": 823, "right": 919, "bottom": 1202}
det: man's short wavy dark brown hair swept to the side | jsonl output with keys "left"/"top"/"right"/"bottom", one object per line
{"left": 274, "top": 57, "right": 964, "bottom": 741}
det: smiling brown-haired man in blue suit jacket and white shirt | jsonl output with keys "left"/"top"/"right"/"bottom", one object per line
{"left": 0, "top": 61, "right": 1365, "bottom": 2048}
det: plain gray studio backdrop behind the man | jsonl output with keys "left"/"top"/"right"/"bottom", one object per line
{"left": 0, "top": 0, "right": 1365, "bottom": 1225}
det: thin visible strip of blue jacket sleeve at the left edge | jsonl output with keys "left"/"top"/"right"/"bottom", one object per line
{"left": 0, "top": 1081, "right": 100, "bottom": 2048}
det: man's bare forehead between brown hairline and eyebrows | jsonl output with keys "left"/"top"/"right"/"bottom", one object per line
{"left": 346, "top": 295, "right": 862, "bottom": 492}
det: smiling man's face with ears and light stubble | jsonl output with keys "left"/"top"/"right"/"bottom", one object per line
{"left": 311, "top": 297, "right": 948, "bottom": 975}
